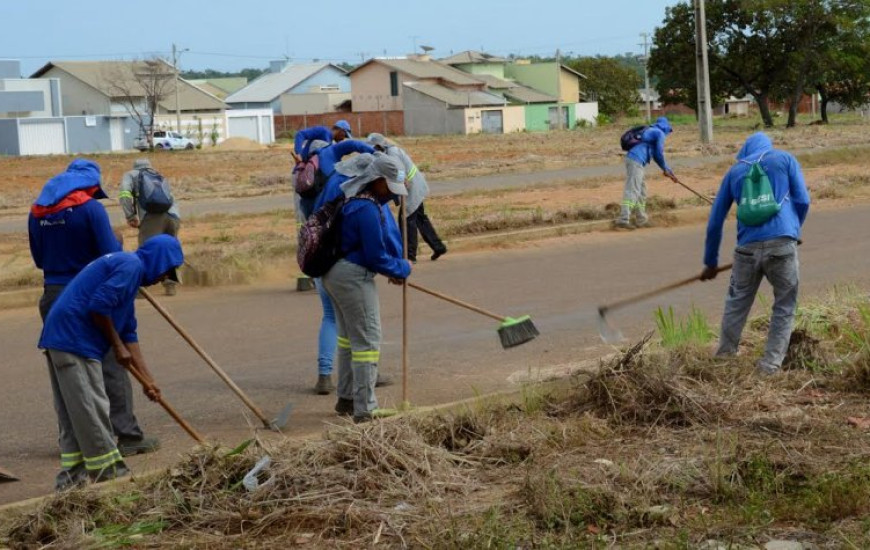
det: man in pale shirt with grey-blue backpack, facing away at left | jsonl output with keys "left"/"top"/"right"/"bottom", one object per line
{"left": 118, "top": 159, "right": 181, "bottom": 296}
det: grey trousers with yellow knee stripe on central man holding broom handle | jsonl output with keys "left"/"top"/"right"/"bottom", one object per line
{"left": 323, "top": 260, "right": 381, "bottom": 418}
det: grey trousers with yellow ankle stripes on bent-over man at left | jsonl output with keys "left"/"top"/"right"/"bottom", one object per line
{"left": 46, "top": 349, "right": 123, "bottom": 476}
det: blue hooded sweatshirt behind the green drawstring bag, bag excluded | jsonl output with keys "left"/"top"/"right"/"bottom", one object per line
{"left": 704, "top": 132, "right": 810, "bottom": 267}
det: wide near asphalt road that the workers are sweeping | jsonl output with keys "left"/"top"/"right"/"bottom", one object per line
{"left": 0, "top": 206, "right": 870, "bottom": 503}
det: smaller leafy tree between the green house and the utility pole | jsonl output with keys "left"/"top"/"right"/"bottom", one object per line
{"left": 566, "top": 56, "right": 642, "bottom": 116}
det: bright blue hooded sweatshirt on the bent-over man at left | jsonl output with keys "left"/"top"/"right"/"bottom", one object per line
{"left": 39, "top": 235, "right": 184, "bottom": 360}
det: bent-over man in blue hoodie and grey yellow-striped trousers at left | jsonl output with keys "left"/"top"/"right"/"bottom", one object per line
{"left": 39, "top": 235, "right": 184, "bottom": 490}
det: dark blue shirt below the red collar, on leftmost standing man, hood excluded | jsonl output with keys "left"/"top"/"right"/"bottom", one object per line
{"left": 27, "top": 199, "right": 121, "bottom": 285}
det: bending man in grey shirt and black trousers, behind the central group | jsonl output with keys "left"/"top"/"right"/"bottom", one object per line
{"left": 368, "top": 133, "right": 447, "bottom": 262}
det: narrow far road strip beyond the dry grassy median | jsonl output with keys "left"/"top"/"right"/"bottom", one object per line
{"left": 0, "top": 155, "right": 731, "bottom": 233}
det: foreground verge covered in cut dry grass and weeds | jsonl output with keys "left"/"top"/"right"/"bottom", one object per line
{"left": 0, "top": 290, "right": 870, "bottom": 548}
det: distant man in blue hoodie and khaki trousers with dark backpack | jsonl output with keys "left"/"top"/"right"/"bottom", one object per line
{"left": 614, "top": 117, "right": 677, "bottom": 230}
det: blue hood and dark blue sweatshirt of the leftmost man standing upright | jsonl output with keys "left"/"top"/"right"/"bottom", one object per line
{"left": 27, "top": 159, "right": 121, "bottom": 285}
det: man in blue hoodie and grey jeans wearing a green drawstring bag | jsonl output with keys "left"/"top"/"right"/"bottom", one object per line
{"left": 701, "top": 132, "right": 810, "bottom": 374}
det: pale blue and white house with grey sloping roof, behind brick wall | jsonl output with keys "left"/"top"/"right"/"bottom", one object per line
{"left": 227, "top": 61, "right": 351, "bottom": 115}
